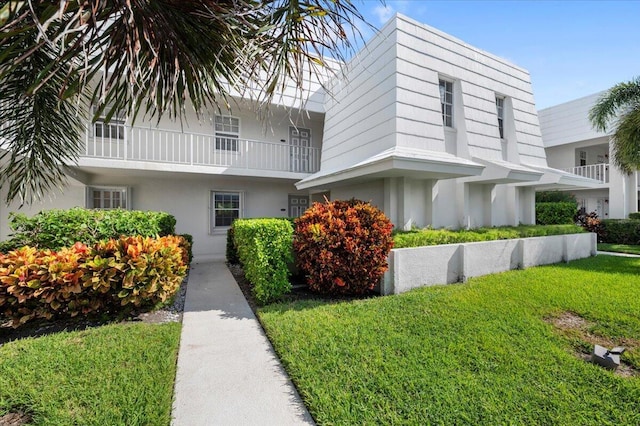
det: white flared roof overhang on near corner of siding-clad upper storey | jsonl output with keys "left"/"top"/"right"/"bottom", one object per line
{"left": 296, "top": 147, "right": 485, "bottom": 190}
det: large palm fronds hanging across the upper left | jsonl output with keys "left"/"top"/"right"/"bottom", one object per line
{"left": 0, "top": 0, "right": 372, "bottom": 201}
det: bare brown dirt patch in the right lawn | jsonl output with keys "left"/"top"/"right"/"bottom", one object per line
{"left": 546, "top": 312, "right": 640, "bottom": 377}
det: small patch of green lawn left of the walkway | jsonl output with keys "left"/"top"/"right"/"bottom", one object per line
{"left": 0, "top": 323, "right": 180, "bottom": 425}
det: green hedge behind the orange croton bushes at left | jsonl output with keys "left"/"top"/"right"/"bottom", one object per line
{"left": 0, "top": 207, "right": 176, "bottom": 252}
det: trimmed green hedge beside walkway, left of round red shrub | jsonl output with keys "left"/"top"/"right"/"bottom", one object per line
{"left": 232, "top": 219, "right": 293, "bottom": 304}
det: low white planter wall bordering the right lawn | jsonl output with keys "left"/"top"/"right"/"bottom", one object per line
{"left": 381, "top": 233, "right": 597, "bottom": 294}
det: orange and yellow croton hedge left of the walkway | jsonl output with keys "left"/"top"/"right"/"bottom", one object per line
{"left": 0, "top": 236, "right": 188, "bottom": 326}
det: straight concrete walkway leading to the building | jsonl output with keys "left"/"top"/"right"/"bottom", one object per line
{"left": 172, "top": 262, "right": 314, "bottom": 426}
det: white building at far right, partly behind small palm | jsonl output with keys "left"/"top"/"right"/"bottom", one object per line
{"left": 538, "top": 92, "right": 639, "bottom": 219}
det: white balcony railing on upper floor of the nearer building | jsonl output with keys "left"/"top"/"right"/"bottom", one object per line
{"left": 84, "top": 122, "right": 320, "bottom": 173}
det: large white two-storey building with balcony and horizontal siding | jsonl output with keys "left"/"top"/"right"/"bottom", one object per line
{"left": 0, "top": 15, "right": 594, "bottom": 259}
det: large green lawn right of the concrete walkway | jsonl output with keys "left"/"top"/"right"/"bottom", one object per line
{"left": 259, "top": 256, "right": 640, "bottom": 425}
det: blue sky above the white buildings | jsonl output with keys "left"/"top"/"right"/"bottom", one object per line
{"left": 354, "top": 0, "right": 640, "bottom": 109}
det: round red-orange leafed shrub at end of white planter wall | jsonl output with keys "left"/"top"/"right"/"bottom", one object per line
{"left": 293, "top": 199, "right": 393, "bottom": 295}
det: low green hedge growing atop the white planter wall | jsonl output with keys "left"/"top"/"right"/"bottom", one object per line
{"left": 393, "top": 225, "right": 584, "bottom": 248}
